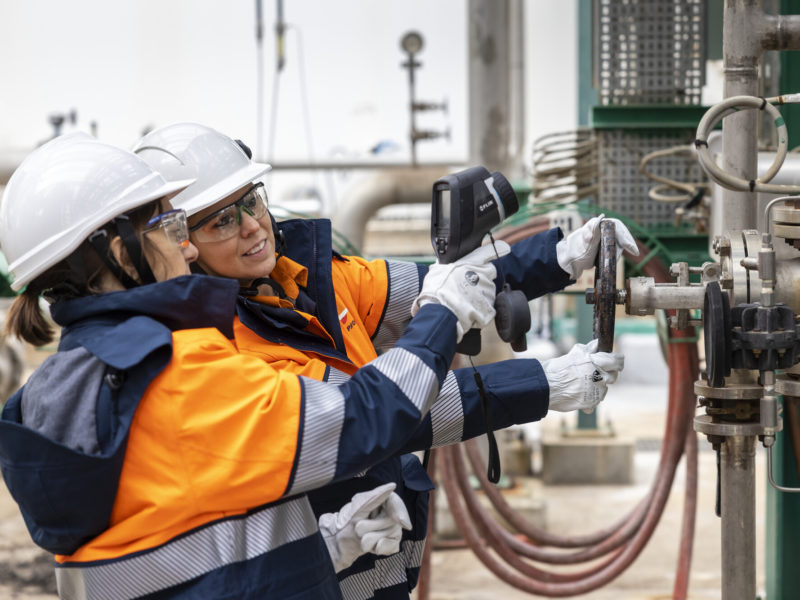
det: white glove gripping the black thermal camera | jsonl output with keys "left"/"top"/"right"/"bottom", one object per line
{"left": 411, "top": 241, "right": 511, "bottom": 342}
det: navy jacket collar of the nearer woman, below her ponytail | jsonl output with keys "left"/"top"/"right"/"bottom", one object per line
{"left": 50, "top": 275, "right": 239, "bottom": 338}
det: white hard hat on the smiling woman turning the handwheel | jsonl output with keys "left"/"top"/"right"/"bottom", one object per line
{"left": 133, "top": 123, "right": 272, "bottom": 216}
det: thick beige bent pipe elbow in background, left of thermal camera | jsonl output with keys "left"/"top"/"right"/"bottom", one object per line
{"left": 332, "top": 167, "right": 448, "bottom": 251}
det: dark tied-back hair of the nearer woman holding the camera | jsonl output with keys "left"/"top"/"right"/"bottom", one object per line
{"left": 5, "top": 200, "right": 158, "bottom": 346}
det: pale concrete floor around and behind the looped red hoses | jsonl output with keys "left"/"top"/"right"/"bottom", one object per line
{"left": 412, "top": 382, "right": 766, "bottom": 600}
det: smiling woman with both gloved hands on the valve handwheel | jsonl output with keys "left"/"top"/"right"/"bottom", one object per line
{"left": 134, "top": 123, "right": 635, "bottom": 598}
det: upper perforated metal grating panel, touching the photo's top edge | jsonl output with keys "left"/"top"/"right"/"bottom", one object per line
{"left": 594, "top": 0, "right": 706, "bottom": 105}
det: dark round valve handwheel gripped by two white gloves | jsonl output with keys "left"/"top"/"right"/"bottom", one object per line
{"left": 593, "top": 220, "right": 617, "bottom": 352}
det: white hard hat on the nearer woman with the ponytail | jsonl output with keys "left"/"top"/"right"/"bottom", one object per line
{"left": 0, "top": 133, "right": 193, "bottom": 291}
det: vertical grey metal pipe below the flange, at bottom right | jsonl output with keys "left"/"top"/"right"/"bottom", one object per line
{"left": 720, "top": 435, "right": 756, "bottom": 600}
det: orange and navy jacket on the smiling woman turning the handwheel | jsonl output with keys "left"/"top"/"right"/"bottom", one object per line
{"left": 235, "top": 220, "right": 568, "bottom": 599}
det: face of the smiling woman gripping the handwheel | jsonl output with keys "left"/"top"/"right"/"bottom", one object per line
{"left": 189, "top": 184, "right": 276, "bottom": 286}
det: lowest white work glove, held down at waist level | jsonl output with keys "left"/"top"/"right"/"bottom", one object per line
{"left": 319, "top": 483, "right": 411, "bottom": 573}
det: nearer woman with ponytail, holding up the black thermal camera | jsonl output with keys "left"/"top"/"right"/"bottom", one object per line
{"left": 0, "top": 134, "right": 495, "bottom": 600}
